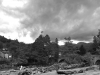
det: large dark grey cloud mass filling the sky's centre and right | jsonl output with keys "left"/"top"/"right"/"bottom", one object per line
{"left": 20, "top": 0, "right": 100, "bottom": 41}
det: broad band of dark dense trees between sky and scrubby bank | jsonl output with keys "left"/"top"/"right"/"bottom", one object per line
{"left": 0, "top": 29, "right": 100, "bottom": 65}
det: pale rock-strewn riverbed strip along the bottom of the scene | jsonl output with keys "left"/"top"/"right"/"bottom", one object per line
{"left": 0, "top": 65, "right": 100, "bottom": 75}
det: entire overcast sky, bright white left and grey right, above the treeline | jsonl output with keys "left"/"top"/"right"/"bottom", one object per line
{"left": 0, "top": 0, "right": 100, "bottom": 43}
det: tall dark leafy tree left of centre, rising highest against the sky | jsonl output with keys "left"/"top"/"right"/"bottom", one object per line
{"left": 31, "top": 35, "right": 50, "bottom": 63}
